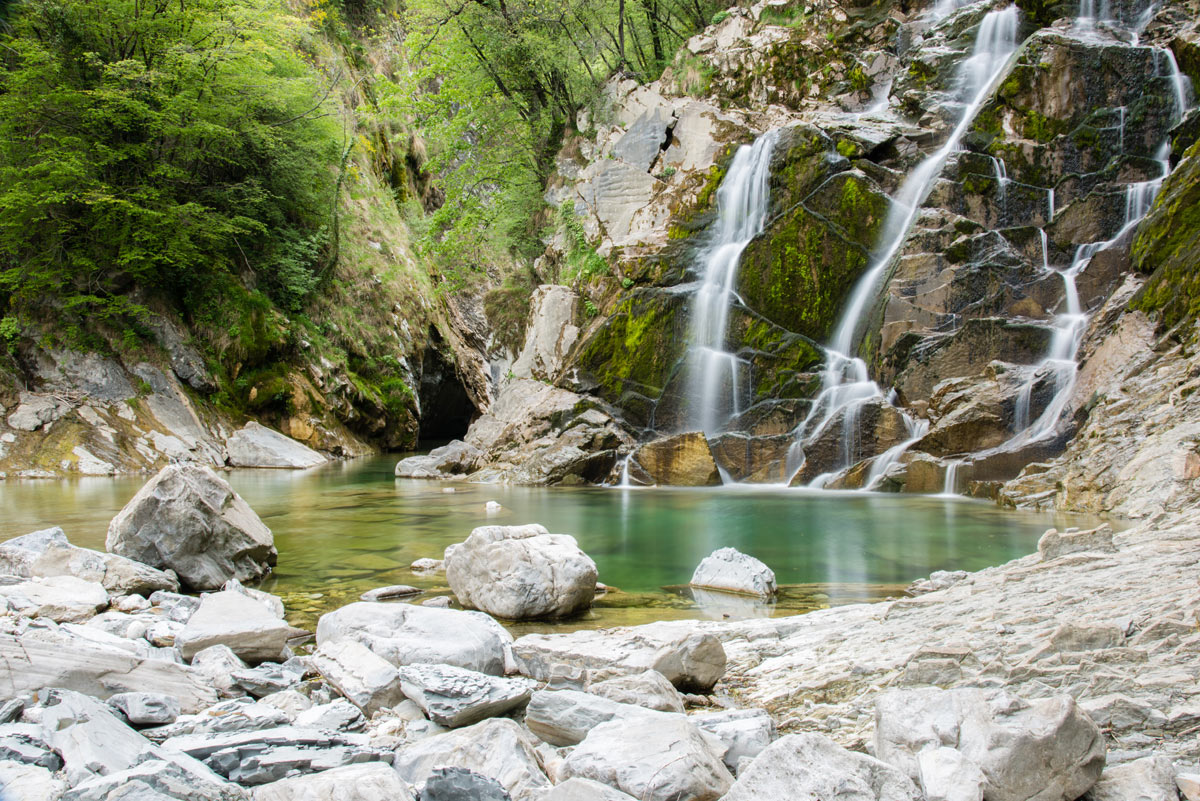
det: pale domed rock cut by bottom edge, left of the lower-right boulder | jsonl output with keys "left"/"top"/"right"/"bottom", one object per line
{"left": 722, "top": 733, "right": 922, "bottom": 801}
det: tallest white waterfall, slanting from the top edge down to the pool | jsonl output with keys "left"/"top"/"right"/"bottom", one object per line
{"left": 787, "top": 6, "right": 1018, "bottom": 486}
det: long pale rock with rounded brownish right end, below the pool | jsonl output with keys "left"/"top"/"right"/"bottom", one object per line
{"left": 512, "top": 621, "right": 725, "bottom": 693}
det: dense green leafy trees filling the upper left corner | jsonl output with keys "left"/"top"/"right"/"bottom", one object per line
{"left": 0, "top": 0, "right": 340, "bottom": 331}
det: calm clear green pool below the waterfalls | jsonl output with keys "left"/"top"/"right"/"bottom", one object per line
{"left": 0, "top": 457, "right": 1104, "bottom": 631}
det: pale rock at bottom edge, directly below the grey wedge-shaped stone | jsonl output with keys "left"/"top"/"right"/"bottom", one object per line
{"left": 396, "top": 718, "right": 550, "bottom": 801}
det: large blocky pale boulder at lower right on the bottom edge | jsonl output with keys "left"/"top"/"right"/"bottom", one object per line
{"left": 875, "top": 688, "right": 1106, "bottom": 801}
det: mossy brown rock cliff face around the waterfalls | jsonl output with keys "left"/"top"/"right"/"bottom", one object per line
{"left": 429, "top": 1, "right": 1200, "bottom": 513}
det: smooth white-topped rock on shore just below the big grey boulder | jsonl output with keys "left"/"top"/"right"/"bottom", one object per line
{"left": 175, "top": 590, "right": 292, "bottom": 663}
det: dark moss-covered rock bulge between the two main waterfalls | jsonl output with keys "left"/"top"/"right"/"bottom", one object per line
{"left": 738, "top": 171, "right": 888, "bottom": 342}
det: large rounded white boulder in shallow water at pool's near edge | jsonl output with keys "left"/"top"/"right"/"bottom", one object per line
{"left": 446, "top": 524, "right": 596, "bottom": 620}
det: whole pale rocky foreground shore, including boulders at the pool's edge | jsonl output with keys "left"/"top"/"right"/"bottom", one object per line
{"left": 0, "top": 466, "right": 1200, "bottom": 801}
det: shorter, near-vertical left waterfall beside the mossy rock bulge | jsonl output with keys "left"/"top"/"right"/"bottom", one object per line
{"left": 688, "top": 131, "right": 779, "bottom": 434}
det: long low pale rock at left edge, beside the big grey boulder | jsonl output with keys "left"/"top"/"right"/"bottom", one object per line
{"left": 0, "top": 528, "right": 179, "bottom": 596}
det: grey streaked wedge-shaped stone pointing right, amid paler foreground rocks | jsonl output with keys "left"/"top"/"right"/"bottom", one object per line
{"left": 400, "top": 664, "right": 530, "bottom": 729}
